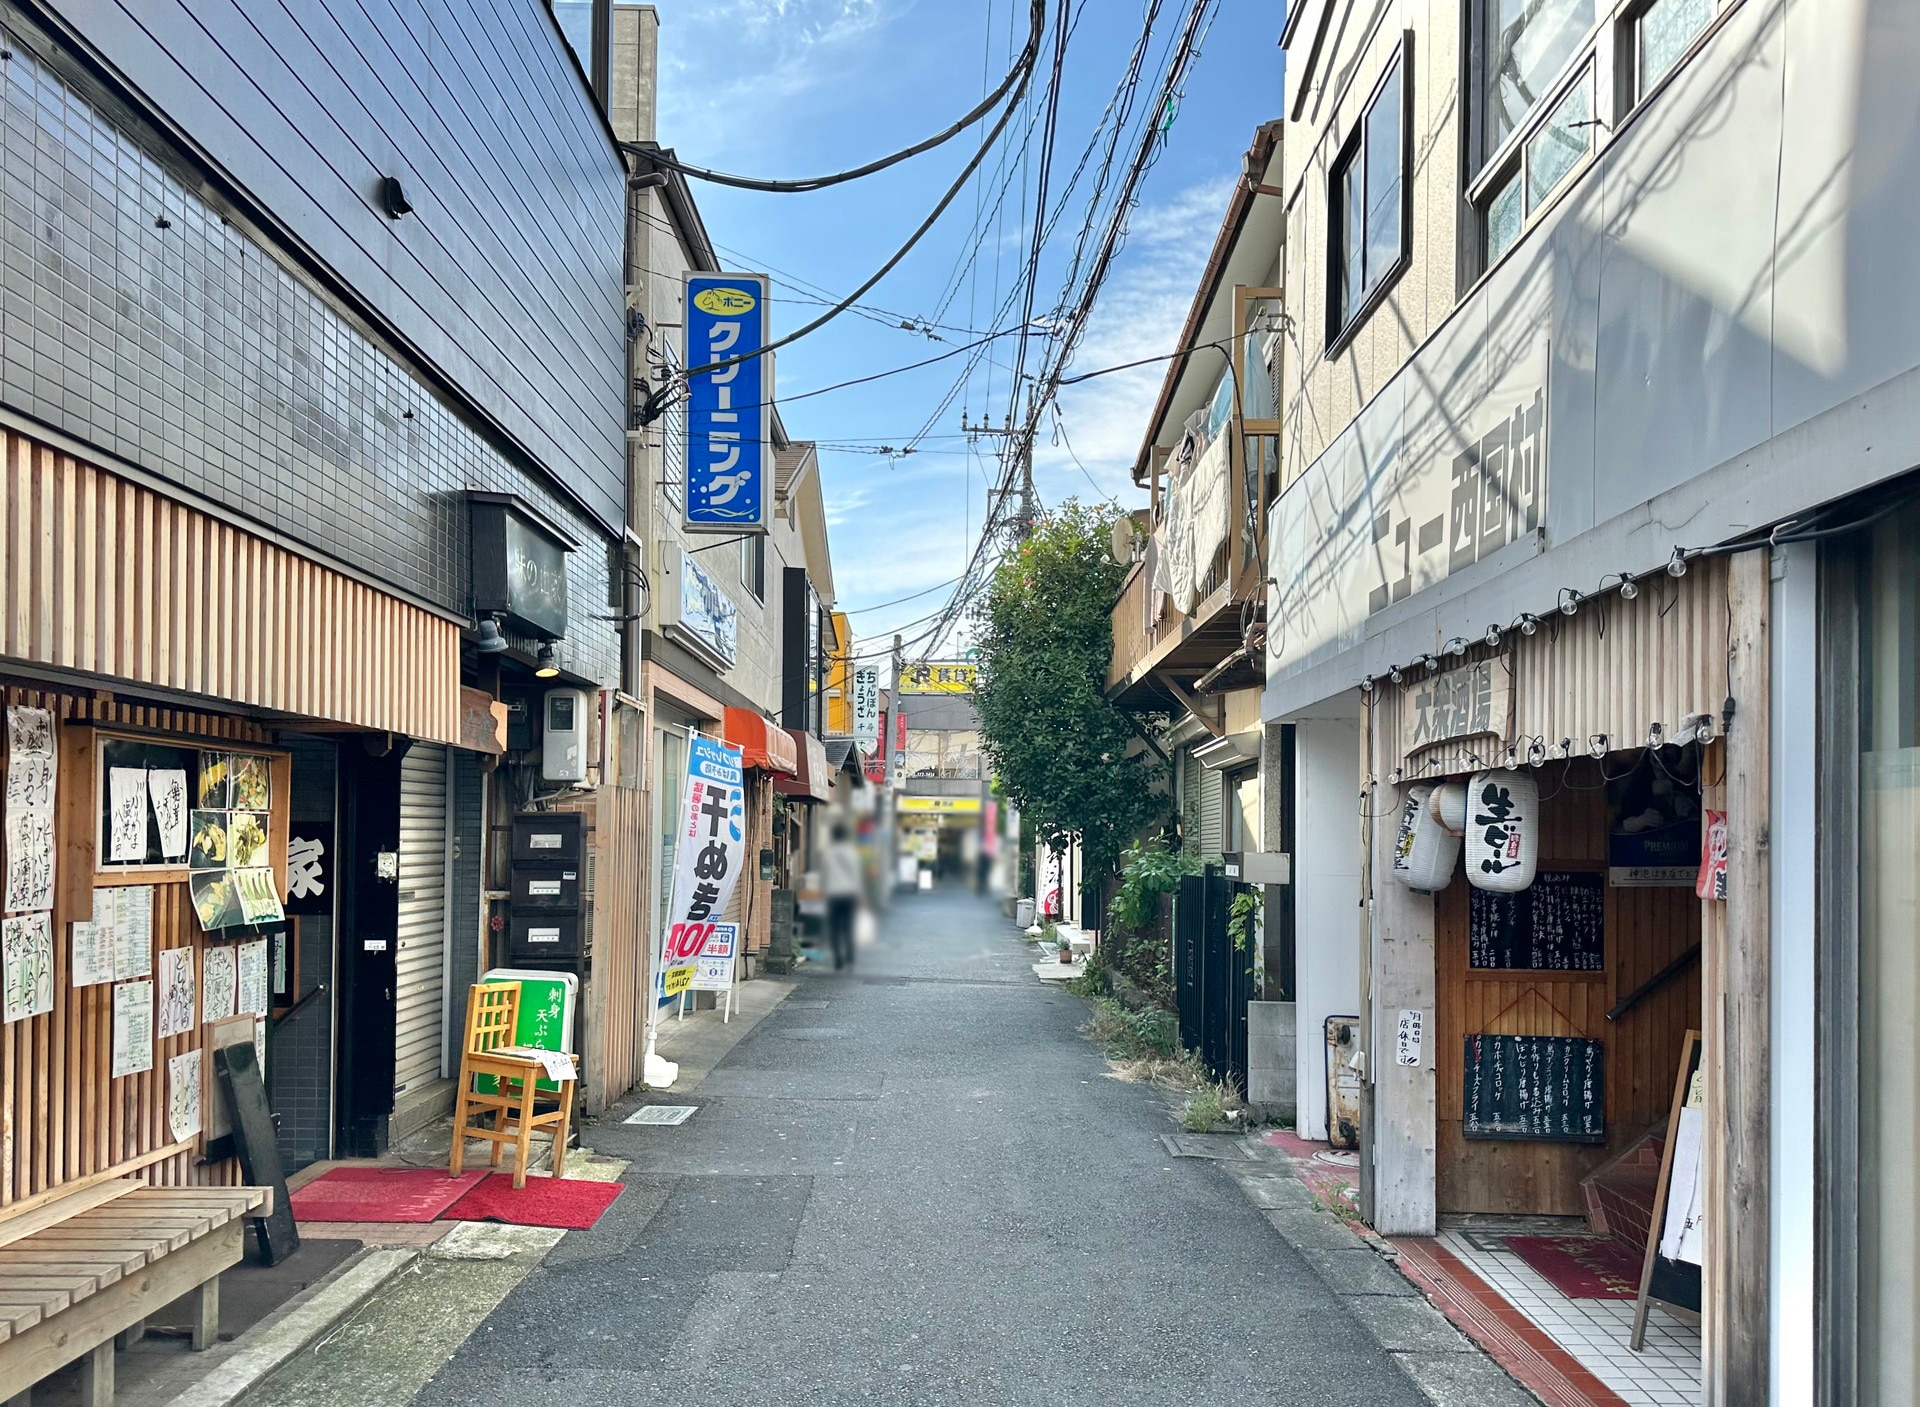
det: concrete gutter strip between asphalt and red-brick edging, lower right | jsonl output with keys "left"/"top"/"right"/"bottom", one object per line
{"left": 1215, "top": 1138, "right": 1538, "bottom": 1407}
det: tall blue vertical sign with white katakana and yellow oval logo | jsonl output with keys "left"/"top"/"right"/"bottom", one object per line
{"left": 680, "top": 273, "right": 774, "bottom": 534}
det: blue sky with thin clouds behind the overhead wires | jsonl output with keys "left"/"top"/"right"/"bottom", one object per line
{"left": 659, "top": 0, "right": 1281, "bottom": 653}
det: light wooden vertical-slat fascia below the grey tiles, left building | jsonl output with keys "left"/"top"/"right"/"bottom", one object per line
{"left": 0, "top": 428, "right": 459, "bottom": 743}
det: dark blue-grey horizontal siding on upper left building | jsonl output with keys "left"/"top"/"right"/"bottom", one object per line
{"left": 31, "top": 0, "right": 626, "bottom": 526}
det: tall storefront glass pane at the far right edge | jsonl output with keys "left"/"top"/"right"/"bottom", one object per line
{"left": 1859, "top": 513, "right": 1920, "bottom": 1407}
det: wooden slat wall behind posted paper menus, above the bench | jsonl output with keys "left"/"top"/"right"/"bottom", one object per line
{"left": 0, "top": 683, "right": 270, "bottom": 1209}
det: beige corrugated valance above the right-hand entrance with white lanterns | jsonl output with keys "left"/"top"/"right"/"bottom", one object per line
{"left": 1380, "top": 557, "right": 1728, "bottom": 781}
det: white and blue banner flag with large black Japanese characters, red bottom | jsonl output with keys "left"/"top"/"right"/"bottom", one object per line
{"left": 659, "top": 733, "right": 747, "bottom": 996}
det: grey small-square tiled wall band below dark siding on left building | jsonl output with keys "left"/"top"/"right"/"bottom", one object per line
{"left": 0, "top": 36, "right": 620, "bottom": 683}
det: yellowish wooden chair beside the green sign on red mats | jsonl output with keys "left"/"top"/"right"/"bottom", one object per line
{"left": 447, "top": 983, "right": 580, "bottom": 1188}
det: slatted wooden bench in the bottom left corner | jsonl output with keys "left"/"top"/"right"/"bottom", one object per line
{"left": 0, "top": 1179, "right": 273, "bottom": 1407}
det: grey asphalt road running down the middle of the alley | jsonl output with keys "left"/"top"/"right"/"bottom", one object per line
{"left": 417, "top": 891, "right": 1427, "bottom": 1407}
